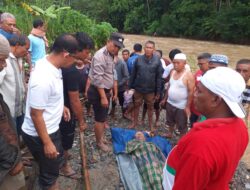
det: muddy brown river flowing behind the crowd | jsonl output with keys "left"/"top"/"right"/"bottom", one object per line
{"left": 124, "top": 34, "right": 250, "bottom": 71}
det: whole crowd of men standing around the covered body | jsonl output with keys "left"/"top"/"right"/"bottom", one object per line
{"left": 0, "top": 13, "right": 250, "bottom": 190}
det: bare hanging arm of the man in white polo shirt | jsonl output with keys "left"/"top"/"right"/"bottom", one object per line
{"left": 30, "top": 108, "right": 59, "bottom": 159}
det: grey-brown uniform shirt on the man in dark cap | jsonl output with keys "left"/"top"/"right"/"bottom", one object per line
{"left": 89, "top": 46, "right": 114, "bottom": 89}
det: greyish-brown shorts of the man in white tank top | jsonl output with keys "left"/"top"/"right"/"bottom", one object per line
{"left": 166, "top": 102, "right": 187, "bottom": 134}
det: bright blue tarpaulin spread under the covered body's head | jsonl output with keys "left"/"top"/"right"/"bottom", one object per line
{"left": 111, "top": 127, "right": 172, "bottom": 157}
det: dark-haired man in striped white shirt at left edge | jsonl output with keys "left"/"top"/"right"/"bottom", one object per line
{"left": 0, "top": 35, "right": 30, "bottom": 135}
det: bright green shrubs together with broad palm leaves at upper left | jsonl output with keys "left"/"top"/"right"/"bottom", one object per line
{"left": 1, "top": 0, "right": 117, "bottom": 48}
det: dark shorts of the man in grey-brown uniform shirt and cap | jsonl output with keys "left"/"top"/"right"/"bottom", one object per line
{"left": 88, "top": 85, "right": 111, "bottom": 123}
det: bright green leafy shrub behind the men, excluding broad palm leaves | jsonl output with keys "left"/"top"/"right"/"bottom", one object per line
{"left": 1, "top": 5, "right": 117, "bottom": 48}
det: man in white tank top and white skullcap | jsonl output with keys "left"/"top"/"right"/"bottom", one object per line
{"left": 162, "top": 53, "right": 195, "bottom": 138}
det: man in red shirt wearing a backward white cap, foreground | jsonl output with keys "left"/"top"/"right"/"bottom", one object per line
{"left": 163, "top": 67, "right": 249, "bottom": 190}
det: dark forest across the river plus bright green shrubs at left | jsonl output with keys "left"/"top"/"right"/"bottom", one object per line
{"left": 0, "top": 0, "right": 250, "bottom": 44}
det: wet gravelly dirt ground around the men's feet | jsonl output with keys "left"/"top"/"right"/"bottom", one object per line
{"left": 53, "top": 110, "right": 250, "bottom": 190}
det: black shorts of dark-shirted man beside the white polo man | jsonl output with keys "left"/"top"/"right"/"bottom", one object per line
{"left": 59, "top": 116, "right": 76, "bottom": 150}
